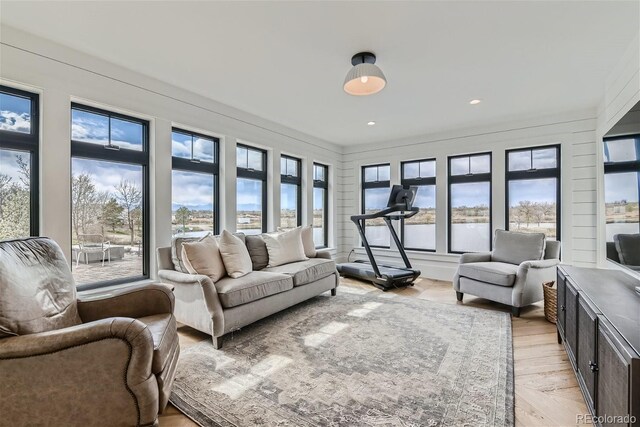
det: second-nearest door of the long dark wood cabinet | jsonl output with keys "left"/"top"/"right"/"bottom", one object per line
{"left": 576, "top": 295, "right": 598, "bottom": 409}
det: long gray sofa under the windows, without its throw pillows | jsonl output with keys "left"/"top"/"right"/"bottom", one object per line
{"left": 157, "top": 234, "right": 339, "bottom": 348}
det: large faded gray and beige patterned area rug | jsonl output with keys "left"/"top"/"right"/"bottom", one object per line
{"left": 171, "top": 286, "right": 514, "bottom": 427}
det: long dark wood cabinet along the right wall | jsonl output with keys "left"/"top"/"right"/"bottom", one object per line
{"left": 557, "top": 266, "right": 640, "bottom": 427}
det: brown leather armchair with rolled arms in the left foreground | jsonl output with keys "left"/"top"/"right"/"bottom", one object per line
{"left": 0, "top": 238, "right": 179, "bottom": 426}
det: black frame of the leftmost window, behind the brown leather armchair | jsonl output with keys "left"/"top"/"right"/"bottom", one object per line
{"left": 0, "top": 85, "right": 40, "bottom": 237}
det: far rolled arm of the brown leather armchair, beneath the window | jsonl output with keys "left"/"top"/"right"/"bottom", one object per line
{"left": 78, "top": 283, "right": 174, "bottom": 323}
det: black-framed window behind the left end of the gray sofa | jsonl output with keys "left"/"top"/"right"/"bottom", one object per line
{"left": 171, "top": 128, "right": 220, "bottom": 235}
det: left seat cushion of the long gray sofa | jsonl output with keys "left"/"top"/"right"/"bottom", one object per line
{"left": 215, "top": 271, "right": 293, "bottom": 308}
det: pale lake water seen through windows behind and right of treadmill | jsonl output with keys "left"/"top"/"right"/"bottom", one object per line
{"left": 365, "top": 223, "right": 491, "bottom": 252}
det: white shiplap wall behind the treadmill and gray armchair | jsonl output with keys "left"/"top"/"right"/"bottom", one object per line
{"left": 337, "top": 109, "right": 597, "bottom": 280}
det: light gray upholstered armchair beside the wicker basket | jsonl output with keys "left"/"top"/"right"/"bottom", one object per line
{"left": 453, "top": 230, "right": 560, "bottom": 317}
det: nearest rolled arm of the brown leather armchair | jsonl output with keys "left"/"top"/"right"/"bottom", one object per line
{"left": 0, "top": 318, "right": 158, "bottom": 425}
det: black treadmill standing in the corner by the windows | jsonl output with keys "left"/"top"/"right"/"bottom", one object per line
{"left": 337, "top": 185, "right": 420, "bottom": 291}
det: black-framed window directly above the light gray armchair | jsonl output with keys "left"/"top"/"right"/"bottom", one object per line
{"left": 506, "top": 145, "right": 560, "bottom": 240}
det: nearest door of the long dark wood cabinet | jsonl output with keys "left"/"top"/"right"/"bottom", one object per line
{"left": 596, "top": 318, "right": 631, "bottom": 426}
